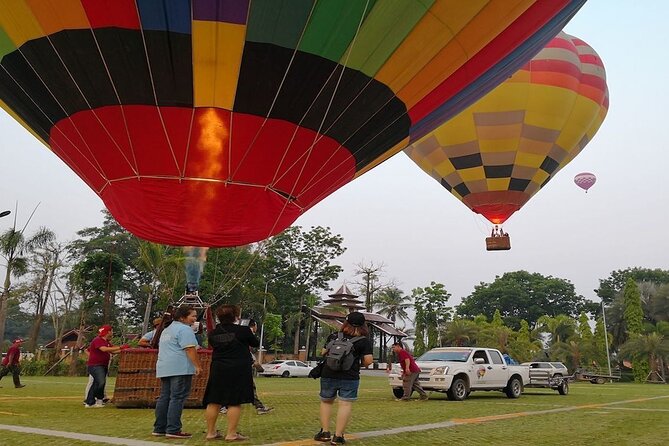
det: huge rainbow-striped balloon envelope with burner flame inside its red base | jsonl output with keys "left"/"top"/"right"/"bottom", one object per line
{"left": 0, "top": 0, "right": 585, "bottom": 246}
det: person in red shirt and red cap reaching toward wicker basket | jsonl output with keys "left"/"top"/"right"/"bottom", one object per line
{"left": 84, "top": 325, "right": 129, "bottom": 408}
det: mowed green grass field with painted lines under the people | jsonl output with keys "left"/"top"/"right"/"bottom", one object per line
{"left": 0, "top": 376, "right": 669, "bottom": 446}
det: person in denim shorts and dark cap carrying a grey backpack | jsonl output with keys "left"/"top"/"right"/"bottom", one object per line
{"left": 314, "top": 311, "right": 374, "bottom": 444}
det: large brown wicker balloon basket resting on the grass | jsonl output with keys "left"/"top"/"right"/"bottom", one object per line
{"left": 113, "top": 348, "right": 211, "bottom": 408}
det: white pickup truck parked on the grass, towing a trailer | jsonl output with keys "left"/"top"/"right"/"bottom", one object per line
{"left": 388, "top": 347, "right": 530, "bottom": 401}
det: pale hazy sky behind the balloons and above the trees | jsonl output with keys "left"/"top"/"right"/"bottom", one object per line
{"left": 0, "top": 0, "right": 669, "bottom": 305}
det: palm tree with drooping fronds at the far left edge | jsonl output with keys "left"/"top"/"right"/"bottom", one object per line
{"left": 0, "top": 225, "right": 55, "bottom": 345}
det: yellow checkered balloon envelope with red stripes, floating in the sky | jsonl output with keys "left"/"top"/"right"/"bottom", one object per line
{"left": 405, "top": 33, "right": 609, "bottom": 224}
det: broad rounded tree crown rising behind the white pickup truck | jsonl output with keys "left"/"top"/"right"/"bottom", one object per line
{"left": 457, "top": 271, "right": 589, "bottom": 330}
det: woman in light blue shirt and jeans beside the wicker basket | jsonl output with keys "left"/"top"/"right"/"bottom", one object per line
{"left": 151, "top": 305, "right": 201, "bottom": 439}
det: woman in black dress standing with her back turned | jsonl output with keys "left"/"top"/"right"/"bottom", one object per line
{"left": 203, "top": 305, "right": 260, "bottom": 441}
